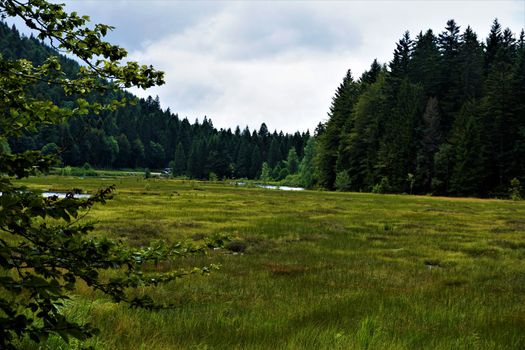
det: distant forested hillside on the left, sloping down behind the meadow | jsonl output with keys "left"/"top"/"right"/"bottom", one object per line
{"left": 0, "top": 22, "right": 309, "bottom": 179}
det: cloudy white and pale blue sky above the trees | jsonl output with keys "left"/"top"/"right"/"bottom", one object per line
{"left": 7, "top": 0, "right": 525, "bottom": 132}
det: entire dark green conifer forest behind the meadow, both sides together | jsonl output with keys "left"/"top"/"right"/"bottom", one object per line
{"left": 0, "top": 19, "right": 525, "bottom": 197}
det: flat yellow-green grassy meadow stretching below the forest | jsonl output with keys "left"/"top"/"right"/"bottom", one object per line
{"left": 14, "top": 176, "right": 525, "bottom": 349}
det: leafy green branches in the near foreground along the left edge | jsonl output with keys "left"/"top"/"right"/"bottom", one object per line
{"left": 0, "top": 0, "right": 219, "bottom": 349}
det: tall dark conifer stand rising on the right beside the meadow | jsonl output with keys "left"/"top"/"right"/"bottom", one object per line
{"left": 317, "top": 20, "right": 525, "bottom": 196}
